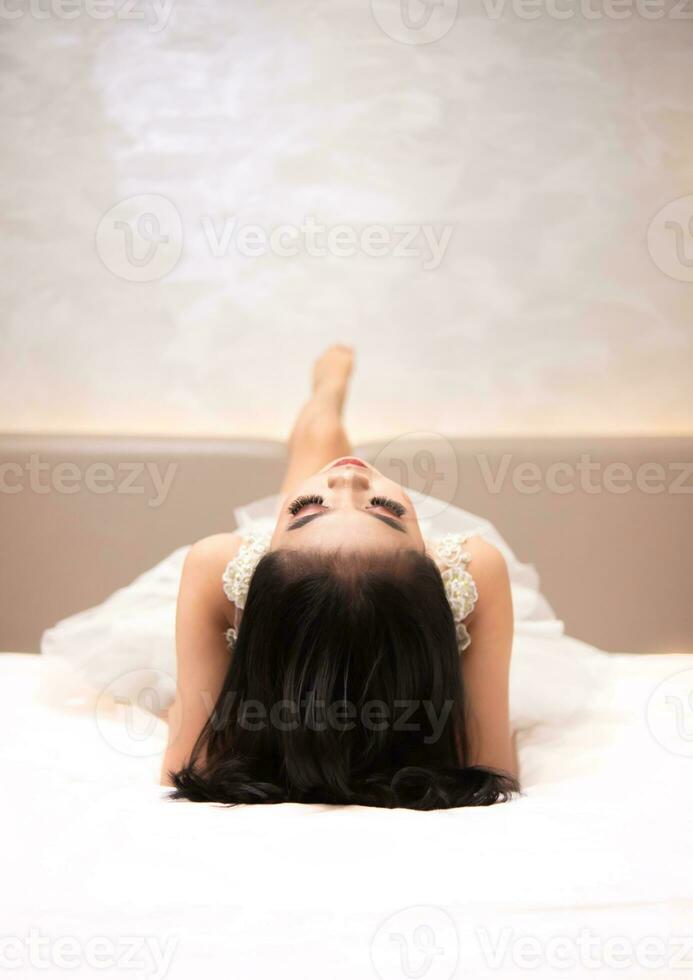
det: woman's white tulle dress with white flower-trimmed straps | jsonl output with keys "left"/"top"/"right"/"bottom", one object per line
{"left": 41, "top": 491, "right": 562, "bottom": 709}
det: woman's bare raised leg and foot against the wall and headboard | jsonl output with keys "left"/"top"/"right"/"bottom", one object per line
{"left": 281, "top": 345, "right": 354, "bottom": 494}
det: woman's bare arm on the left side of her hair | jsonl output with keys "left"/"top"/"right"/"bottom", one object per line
{"left": 161, "top": 534, "right": 241, "bottom": 785}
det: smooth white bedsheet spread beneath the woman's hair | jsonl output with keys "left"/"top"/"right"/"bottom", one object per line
{"left": 0, "top": 644, "right": 693, "bottom": 980}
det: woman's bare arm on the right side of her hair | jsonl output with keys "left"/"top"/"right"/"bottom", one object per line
{"left": 462, "top": 537, "right": 518, "bottom": 776}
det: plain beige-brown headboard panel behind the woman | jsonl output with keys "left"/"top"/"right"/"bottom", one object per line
{"left": 0, "top": 435, "right": 693, "bottom": 652}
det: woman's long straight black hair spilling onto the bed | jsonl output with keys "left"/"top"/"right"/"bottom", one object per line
{"left": 171, "top": 550, "right": 518, "bottom": 810}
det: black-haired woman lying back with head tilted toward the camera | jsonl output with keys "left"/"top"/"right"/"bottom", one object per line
{"left": 163, "top": 347, "right": 517, "bottom": 810}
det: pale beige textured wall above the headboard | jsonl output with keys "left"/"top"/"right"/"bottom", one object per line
{"left": 0, "top": 0, "right": 693, "bottom": 439}
